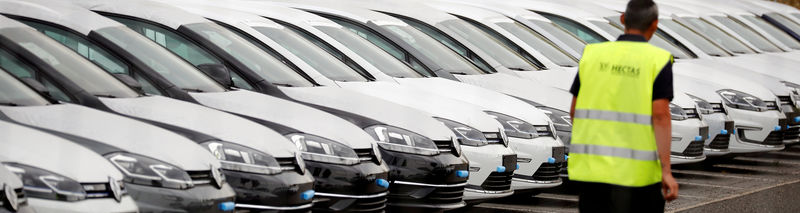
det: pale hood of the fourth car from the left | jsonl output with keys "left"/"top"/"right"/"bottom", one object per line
{"left": 189, "top": 90, "right": 374, "bottom": 149}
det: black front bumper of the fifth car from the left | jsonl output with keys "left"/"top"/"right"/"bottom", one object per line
{"left": 381, "top": 149, "right": 469, "bottom": 209}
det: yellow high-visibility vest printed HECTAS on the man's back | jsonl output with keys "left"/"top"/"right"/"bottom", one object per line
{"left": 568, "top": 41, "right": 672, "bottom": 187}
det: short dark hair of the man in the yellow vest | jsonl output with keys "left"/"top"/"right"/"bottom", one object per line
{"left": 625, "top": 0, "right": 658, "bottom": 31}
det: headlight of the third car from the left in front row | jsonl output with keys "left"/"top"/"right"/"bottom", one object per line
{"left": 202, "top": 141, "right": 282, "bottom": 174}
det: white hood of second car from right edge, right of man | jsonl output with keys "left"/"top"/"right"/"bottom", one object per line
{"left": 672, "top": 59, "right": 789, "bottom": 97}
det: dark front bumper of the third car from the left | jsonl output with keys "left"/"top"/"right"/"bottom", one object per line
{"left": 224, "top": 170, "right": 314, "bottom": 211}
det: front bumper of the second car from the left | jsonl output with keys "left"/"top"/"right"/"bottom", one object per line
{"left": 126, "top": 183, "right": 236, "bottom": 212}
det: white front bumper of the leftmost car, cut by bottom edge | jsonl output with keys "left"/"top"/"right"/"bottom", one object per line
{"left": 25, "top": 196, "right": 138, "bottom": 213}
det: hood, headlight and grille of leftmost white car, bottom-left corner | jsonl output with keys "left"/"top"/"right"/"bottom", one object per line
{"left": 0, "top": 120, "right": 139, "bottom": 212}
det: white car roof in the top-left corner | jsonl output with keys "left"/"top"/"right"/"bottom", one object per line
{"left": 0, "top": 0, "right": 124, "bottom": 35}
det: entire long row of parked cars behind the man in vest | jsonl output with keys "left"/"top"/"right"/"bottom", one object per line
{"left": 0, "top": 0, "right": 800, "bottom": 212}
